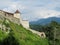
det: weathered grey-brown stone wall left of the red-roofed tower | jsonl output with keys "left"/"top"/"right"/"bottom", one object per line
{"left": 0, "top": 11, "right": 20, "bottom": 24}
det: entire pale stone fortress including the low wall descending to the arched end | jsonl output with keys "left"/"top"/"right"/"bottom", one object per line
{"left": 0, "top": 10, "right": 46, "bottom": 38}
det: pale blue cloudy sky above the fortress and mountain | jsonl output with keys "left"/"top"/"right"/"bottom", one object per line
{"left": 0, "top": 0, "right": 60, "bottom": 21}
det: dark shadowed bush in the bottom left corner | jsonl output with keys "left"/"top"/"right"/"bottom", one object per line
{"left": 1, "top": 33, "right": 19, "bottom": 45}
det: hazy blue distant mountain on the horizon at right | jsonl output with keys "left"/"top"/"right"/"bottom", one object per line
{"left": 30, "top": 17, "right": 60, "bottom": 25}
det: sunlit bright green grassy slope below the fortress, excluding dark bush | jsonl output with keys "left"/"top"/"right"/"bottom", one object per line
{"left": 0, "top": 22, "right": 48, "bottom": 45}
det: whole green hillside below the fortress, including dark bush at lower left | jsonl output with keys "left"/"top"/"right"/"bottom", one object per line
{"left": 0, "top": 20, "right": 49, "bottom": 45}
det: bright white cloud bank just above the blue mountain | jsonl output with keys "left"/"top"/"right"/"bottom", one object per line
{"left": 34, "top": 9, "right": 60, "bottom": 19}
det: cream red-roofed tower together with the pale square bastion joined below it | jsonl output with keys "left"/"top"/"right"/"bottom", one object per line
{"left": 14, "top": 10, "right": 29, "bottom": 28}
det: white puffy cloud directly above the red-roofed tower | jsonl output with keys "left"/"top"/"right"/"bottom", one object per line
{"left": 3, "top": 2, "right": 26, "bottom": 12}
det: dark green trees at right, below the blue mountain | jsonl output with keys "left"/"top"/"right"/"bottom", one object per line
{"left": 31, "top": 21, "right": 60, "bottom": 45}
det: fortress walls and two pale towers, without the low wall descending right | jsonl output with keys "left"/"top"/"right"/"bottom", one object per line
{"left": 0, "top": 10, "right": 29, "bottom": 28}
